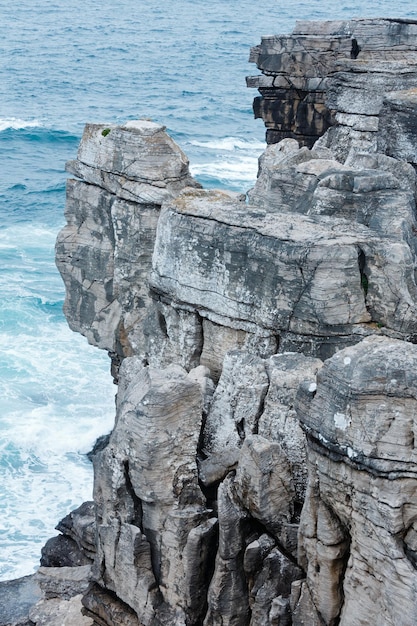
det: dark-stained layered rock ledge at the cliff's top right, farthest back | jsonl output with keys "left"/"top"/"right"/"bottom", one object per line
{"left": 247, "top": 18, "right": 417, "bottom": 149}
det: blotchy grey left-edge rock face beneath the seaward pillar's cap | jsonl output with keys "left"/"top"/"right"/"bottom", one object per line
{"left": 56, "top": 180, "right": 121, "bottom": 350}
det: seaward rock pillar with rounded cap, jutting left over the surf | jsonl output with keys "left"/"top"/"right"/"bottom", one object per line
{"left": 56, "top": 120, "right": 202, "bottom": 357}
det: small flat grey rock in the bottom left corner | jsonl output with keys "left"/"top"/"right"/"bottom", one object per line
{"left": 0, "top": 575, "right": 42, "bottom": 626}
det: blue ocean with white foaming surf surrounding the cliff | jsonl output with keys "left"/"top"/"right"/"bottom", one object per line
{"left": 0, "top": 0, "right": 417, "bottom": 580}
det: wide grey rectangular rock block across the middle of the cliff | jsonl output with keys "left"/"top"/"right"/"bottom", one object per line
{"left": 152, "top": 192, "right": 372, "bottom": 333}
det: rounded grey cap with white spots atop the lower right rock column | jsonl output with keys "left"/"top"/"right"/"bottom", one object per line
{"left": 300, "top": 337, "right": 417, "bottom": 472}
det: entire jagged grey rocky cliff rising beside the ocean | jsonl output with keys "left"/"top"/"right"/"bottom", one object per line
{"left": 17, "top": 20, "right": 417, "bottom": 626}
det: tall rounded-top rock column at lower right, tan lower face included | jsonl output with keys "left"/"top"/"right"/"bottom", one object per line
{"left": 294, "top": 338, "right": 417, "bottom": 626}
